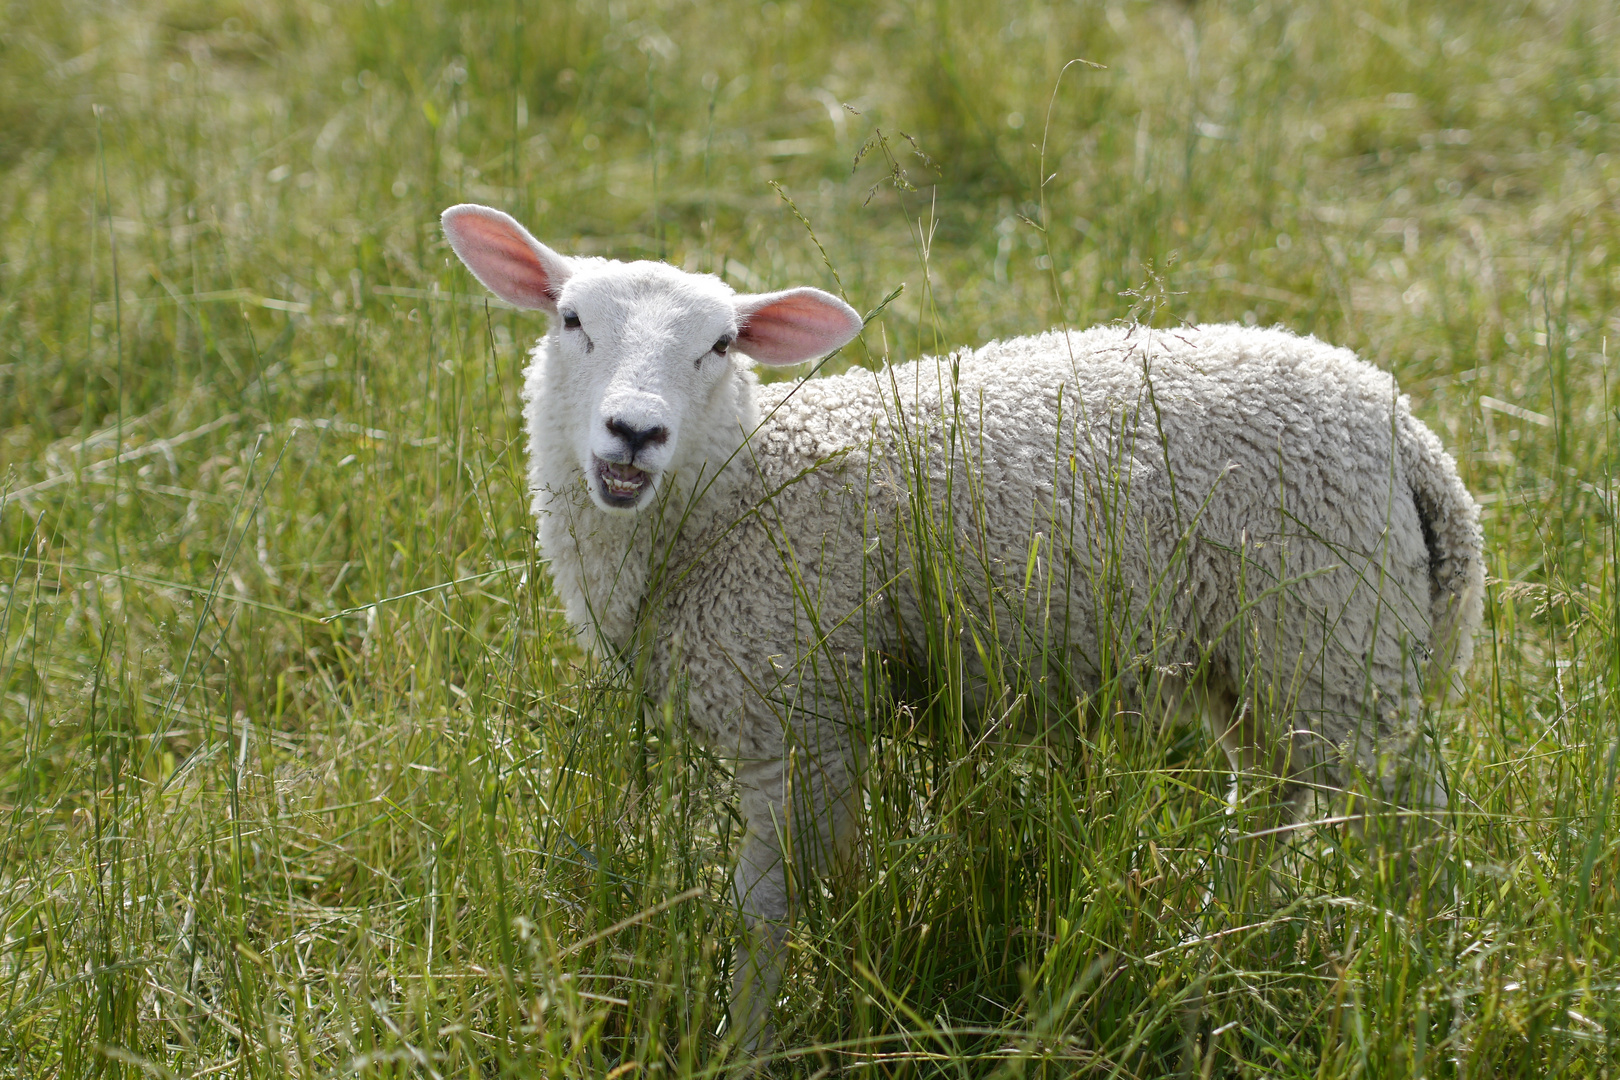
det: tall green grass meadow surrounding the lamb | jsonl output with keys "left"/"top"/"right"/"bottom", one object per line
{"left": 0, "top": 0, "right": 1620, "bottom": 1078}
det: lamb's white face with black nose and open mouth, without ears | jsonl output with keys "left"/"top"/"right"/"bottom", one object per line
{"left": 551, "top": 262, "right": 737, "bottom": 512}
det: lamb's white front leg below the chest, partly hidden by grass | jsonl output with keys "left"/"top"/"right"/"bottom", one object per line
{"left": 731, "top": 751, "right": 857, "bottom": 1054}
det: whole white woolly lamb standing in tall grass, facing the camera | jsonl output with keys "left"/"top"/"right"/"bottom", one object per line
{"left": 442, "top": 204, "right": 1484, "bottom": 1048}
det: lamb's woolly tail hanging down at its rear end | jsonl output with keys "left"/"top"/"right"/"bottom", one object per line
{"left": 1396, "top": 397, "right": 1486, "bottom": 696}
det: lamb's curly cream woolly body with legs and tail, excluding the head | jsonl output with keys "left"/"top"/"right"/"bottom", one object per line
{"left": 530, "top": 327, "right": 1482, "bottom": 1049}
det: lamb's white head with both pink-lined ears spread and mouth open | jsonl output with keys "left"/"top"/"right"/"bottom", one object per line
{"left": 442, "top": 204, "right": 860, "bottom": 510}
